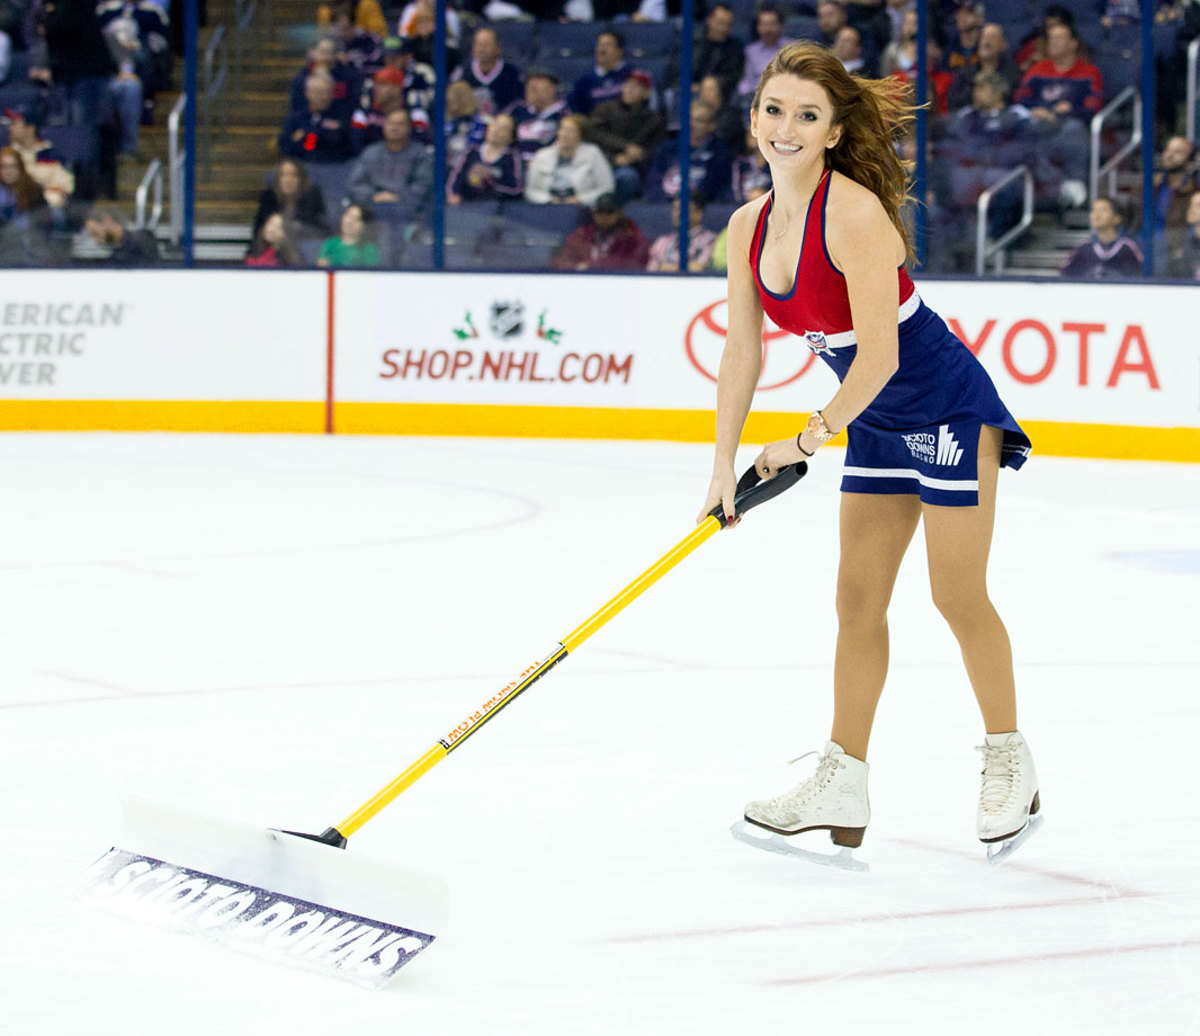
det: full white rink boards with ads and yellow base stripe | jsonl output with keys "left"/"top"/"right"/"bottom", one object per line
{"left": 0, "top": 270, "right": 1200, "bottom": 461}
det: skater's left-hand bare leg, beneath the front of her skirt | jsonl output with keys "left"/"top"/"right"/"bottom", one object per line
{"left": 830, "top": 493, "right": 920, "bottom": 761}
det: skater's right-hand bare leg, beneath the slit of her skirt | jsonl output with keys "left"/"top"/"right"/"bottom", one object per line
{"left": 923, "top": 426, "right": 1016, "bottom": 733}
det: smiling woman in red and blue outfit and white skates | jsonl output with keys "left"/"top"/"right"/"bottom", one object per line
{"left": 701, "top": 43, "right": 1039, "bottom": 846}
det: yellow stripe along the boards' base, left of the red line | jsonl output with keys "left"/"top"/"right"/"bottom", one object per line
{"left": 0, "top": 400, "right": 325, "bottom": 433}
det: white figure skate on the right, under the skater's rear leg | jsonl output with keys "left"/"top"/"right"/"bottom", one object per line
{"left": 977, "top": 730, "right": 1042, "bottom": 862}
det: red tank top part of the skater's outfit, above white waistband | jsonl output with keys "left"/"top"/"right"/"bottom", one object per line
{"left": 750, "top": 169, "right": 914, "bottom": 336}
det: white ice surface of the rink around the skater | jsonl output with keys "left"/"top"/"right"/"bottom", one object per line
{"left": 0, "top": 433, "right": 1200, "bottom": 1036}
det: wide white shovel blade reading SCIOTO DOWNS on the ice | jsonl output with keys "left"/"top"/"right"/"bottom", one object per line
{"left": 80, "top": 796, "right": 449, "bottom": 987}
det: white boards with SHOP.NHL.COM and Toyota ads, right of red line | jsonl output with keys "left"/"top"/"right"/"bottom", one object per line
{"left": 335, "top": 274, "right": 1200, "bottom": 453}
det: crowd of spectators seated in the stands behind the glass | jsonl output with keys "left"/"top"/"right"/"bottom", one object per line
{"left": 0, "top": 0, "right": 1200, "bottom": 277}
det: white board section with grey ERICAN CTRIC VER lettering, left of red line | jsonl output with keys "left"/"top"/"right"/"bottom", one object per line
{"left": 0, "top": 270, "right": 328, "bottom": 431}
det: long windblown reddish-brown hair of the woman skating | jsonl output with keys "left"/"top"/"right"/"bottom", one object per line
{"left": 752, "top": 43, "right": 917, "bottom": 258}
